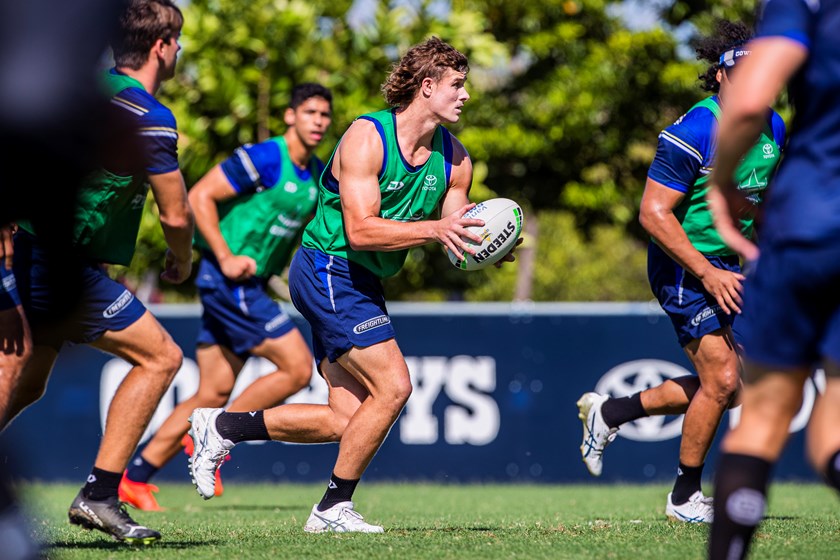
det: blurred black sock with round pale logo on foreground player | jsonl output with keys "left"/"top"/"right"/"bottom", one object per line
{"left": 709, "top": 453, "right": 773, "bottom": 560}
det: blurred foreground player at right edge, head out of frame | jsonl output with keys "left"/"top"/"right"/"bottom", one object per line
{"left": 709, "top": 0, "right": 840, "bottom": 560}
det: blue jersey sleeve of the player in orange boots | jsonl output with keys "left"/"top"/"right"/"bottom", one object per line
{"left": 221, "top": 140, "right": 323, "bottom": 195}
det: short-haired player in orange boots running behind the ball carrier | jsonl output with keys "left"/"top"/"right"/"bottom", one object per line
{"left": 120, "top": 83, "right": 332, "bottom": 510}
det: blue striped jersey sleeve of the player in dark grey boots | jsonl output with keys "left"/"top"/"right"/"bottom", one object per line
{"left": 105, "top": 68, "right": 178, "bottom": 175}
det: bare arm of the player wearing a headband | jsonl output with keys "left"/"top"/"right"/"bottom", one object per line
{"left": 639, "top": 177, "right": 744, "bottom": 314}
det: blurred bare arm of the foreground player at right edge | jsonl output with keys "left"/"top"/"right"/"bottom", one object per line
{"left": 709, "top": 37, "right": 808, "bottom": 260}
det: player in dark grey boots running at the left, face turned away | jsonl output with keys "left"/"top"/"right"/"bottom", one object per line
{"left": 0, "top": 0, "right": 193, "bottom": 544}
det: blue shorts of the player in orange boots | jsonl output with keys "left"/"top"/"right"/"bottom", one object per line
{"left": 195, "top": 254, "right": 297, "bottom": 359}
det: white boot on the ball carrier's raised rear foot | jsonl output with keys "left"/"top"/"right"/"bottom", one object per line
{"left": 190, "top": 408, "right": 236, "bottom": 500}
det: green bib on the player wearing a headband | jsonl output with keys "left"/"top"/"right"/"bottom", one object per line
{"left": 674, "top": 97, "right": 781, "bottom": 256}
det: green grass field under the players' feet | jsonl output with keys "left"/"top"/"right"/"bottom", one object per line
{"left": 21, "top": 484, "right": 840, "bottom": 560}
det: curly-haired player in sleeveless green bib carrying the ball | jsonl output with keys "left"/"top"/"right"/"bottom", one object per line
{"left": 192, "top": 37, "right": 513, "bottom": 533}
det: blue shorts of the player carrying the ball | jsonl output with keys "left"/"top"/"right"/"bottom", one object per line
{"left": 289, "top": 247, "right": 394, "bottom": 364}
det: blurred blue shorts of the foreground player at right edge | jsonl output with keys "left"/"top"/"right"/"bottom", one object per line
{"left": 743, "top": 242, "right": 840, "bottom": 368}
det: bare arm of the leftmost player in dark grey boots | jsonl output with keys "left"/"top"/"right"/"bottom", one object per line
{"left": 149, "top": 165, "right": 195, "bottom": 284}
